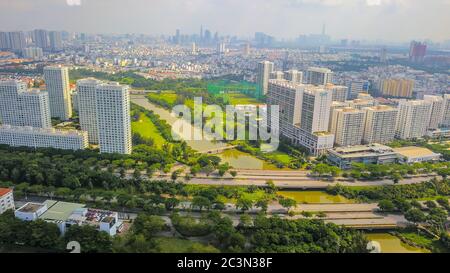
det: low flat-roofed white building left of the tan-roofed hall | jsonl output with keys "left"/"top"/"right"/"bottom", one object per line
{"left": 327, "top": 143, "right": 399, "bottom": 169}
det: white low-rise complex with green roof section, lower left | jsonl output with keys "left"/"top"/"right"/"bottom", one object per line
{"left": 15, "top": 200, "right": 122, "bottom": 236}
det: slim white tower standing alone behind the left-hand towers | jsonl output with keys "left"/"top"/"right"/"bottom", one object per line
{"left": 44, "top": 66, "right": 72, "bottom": 120}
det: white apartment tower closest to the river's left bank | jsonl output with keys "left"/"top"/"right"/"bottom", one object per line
{"left": 95, "top": 83, "right": 132, "bottom": 154}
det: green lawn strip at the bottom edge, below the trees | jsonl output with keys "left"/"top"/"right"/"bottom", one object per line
{"left": 155, "top": 237, "right": 220, "bottom": 253}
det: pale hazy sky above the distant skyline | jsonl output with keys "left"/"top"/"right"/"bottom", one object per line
{"left": 0, "top": 0, "right": 450, "bottom": 41}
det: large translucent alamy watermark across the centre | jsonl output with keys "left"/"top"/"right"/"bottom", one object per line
{"left": 172, "top": 97, "right": 280, "bottom": 152}
